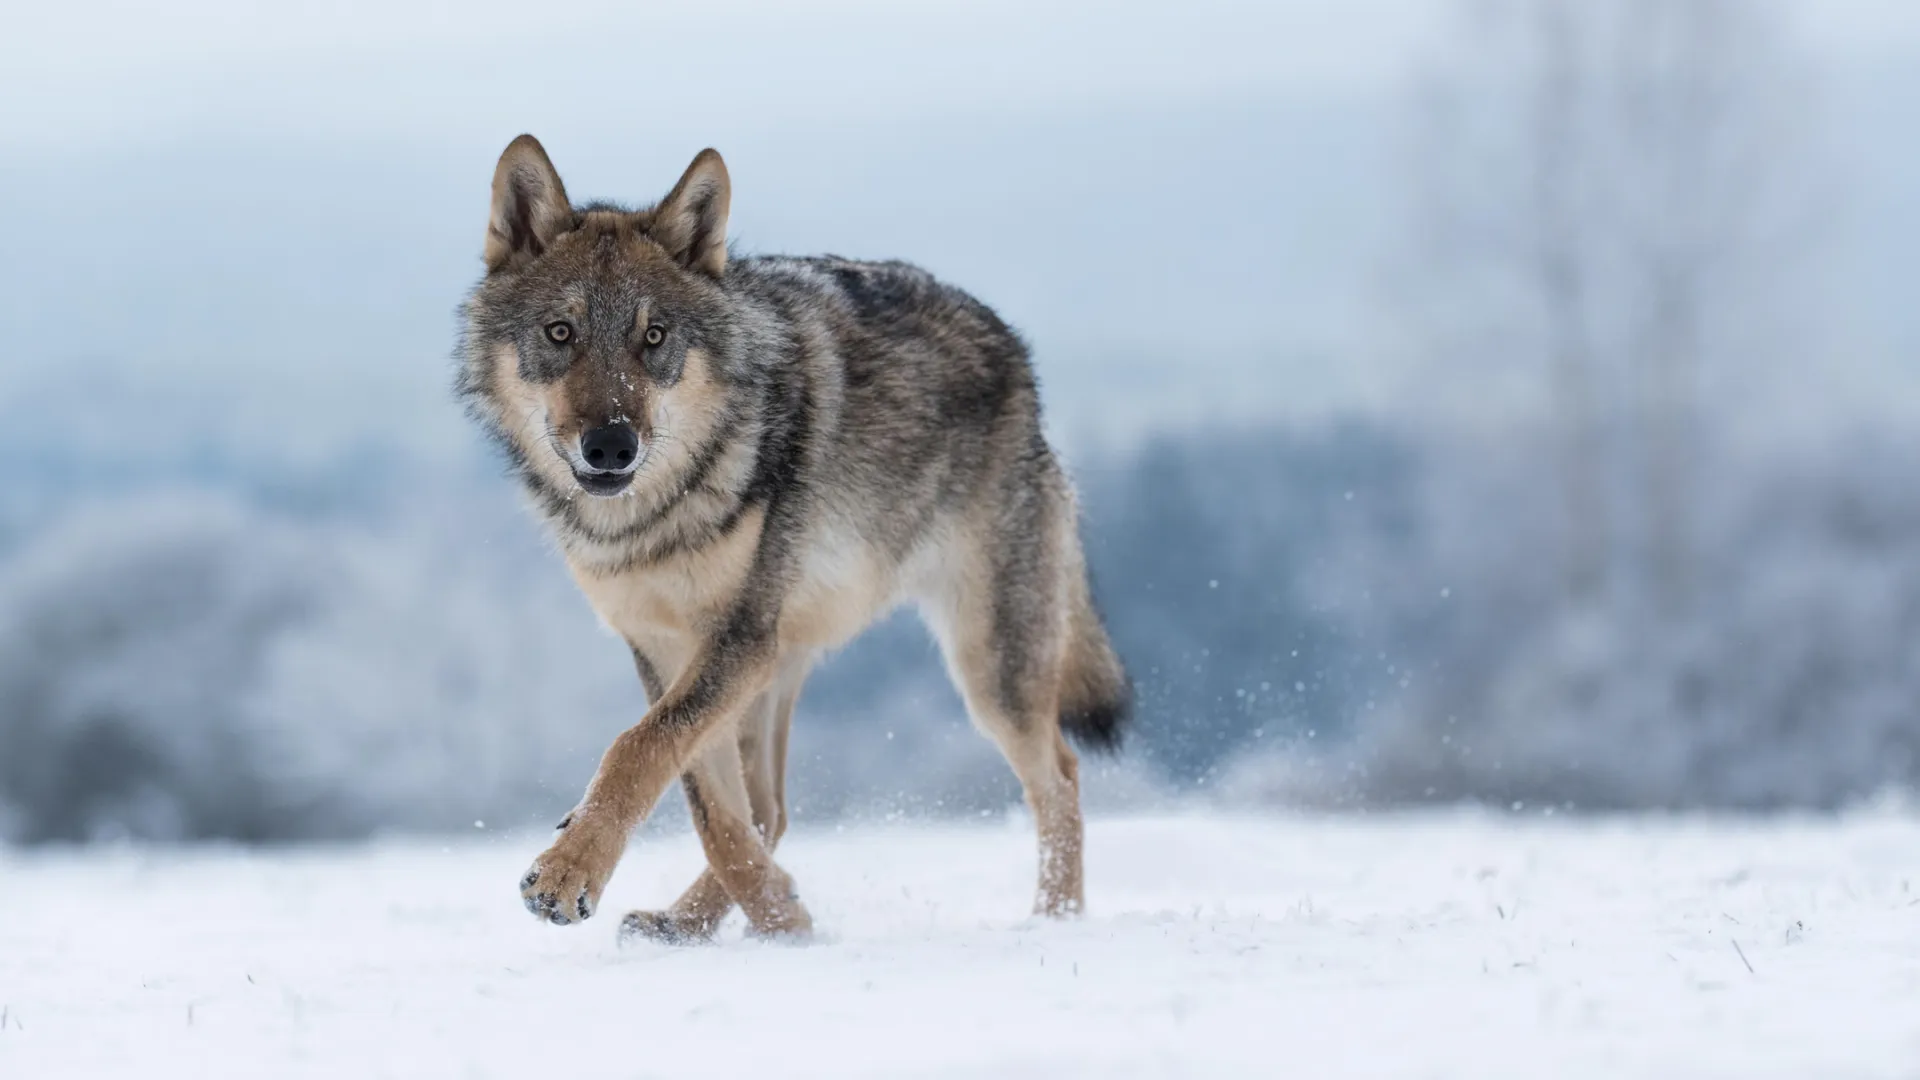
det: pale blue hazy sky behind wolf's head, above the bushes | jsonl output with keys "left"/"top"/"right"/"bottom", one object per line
{"left": 0, "top": 0, "right": 1920, "bottom": 463}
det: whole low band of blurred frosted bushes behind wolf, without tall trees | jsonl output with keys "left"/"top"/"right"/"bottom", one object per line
{"left": 15, "top": 413, "right": 1920, "bottom": 842}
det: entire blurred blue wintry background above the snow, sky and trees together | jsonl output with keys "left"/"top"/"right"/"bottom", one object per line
{"left": 0, "top": 0, "right": 1920, "bottom": 844}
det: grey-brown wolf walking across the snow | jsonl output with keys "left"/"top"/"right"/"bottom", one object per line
{"left": 457, "top": 135, "right": 1133, "bottom": 942}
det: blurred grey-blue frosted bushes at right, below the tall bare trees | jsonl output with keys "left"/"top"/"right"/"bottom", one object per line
{"left": 1235, "top": 424, "right": 1920, "bottom": 809}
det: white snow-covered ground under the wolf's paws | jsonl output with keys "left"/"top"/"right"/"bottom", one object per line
{"left": 0, "top": 809, "right": 1920, "bottom": 1080}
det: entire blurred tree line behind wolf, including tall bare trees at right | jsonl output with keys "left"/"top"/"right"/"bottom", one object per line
{"left": 0, "top": 0, "right": 1920, "bottom": 842}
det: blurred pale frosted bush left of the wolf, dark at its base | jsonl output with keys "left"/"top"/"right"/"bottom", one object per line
{"left": 0, "top": 496, "right": 643, "bottom": 840}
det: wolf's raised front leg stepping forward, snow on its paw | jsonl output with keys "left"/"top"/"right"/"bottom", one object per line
{"left": 520, "top": 632, "right": 774, "bottom": 926}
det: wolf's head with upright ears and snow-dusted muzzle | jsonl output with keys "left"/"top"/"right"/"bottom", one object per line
{"left": 459, "top": 135, "right": 735, "bottom": 498}
